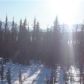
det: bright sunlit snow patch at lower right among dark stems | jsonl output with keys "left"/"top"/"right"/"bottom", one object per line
{"left": 55, "top": 66, "right": 80, "bottom": 84}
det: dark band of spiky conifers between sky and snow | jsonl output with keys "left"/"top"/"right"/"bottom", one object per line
{"left": 0, "top": 16, "right": 84, "bottom": 66}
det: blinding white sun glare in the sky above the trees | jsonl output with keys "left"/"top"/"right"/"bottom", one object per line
{"left": 46, "top": 0, "right": 77, "bottom": 24}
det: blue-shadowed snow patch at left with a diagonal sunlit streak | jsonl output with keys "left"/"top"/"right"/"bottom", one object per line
{"left": 0, "top": 63, "right": 51, "bottom": 84}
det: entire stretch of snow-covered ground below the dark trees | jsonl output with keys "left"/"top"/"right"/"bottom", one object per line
{"left": 0, "top": 62, "right": 83, "bottom": 84}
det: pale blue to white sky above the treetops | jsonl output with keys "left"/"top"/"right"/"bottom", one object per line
{"left": 0, "top": 0, "right": 84, "bottom": 28}
